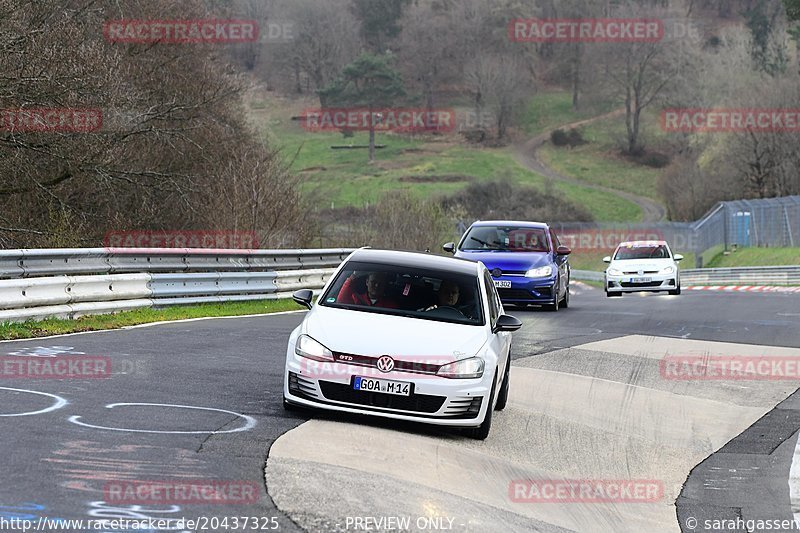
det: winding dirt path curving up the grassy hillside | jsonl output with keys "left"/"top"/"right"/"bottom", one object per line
{"left": 515, "top": 109, "right": 667, "bottom": 222}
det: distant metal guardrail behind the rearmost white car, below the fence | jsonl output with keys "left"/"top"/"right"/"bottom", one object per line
{"left": 571, "top": 266, "right": 800, "bottom": 287}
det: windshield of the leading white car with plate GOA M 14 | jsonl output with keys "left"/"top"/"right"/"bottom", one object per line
{"left": 319, "top": 261, "right": 484, "bottom": 326}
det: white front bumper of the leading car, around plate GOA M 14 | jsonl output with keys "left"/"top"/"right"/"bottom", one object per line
{"left": 283, "top": 343, "right": 493, "bottom": 427}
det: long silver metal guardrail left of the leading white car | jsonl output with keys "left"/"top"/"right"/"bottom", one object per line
{"left": 0, "top": 248, "right": 353, "bottom": 322}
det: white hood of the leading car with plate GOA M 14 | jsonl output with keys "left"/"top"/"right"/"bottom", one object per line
{"left": 301, "top": 305, "right": 487, "bottom": 362}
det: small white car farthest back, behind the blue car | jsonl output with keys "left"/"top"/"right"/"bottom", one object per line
{"left": 603, "top": 241, "right": 683, "bottom": 297}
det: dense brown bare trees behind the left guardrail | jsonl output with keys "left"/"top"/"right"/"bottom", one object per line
{"left": 0, "top": 0, "right": 312, "bottom": 246}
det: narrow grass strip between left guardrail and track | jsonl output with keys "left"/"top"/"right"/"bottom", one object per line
{"left": 0, "top": 299, "right": 301, "bottom": 340}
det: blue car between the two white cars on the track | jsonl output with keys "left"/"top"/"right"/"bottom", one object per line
{"left": 442, "top": 220, "right": 572, "bottom": 311}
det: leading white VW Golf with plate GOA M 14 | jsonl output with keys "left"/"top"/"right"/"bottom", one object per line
{"left": 283, "top": 249, "right": 522, "bottom": 439}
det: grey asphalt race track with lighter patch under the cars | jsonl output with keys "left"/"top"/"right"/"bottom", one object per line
{"left": 0, "top": 286, "right": 800, "bottom": 531}
